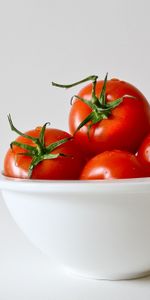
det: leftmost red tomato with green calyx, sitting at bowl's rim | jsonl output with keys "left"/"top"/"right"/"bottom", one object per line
{"left": 4, "top": 116, "right": 84, "bottom": 179}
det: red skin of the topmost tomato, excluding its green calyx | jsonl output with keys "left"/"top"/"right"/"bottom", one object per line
{"left": 69, "top": 79, "right": 150, "bottom": 156}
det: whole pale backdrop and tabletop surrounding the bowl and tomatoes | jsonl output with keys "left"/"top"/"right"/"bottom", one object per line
{"left": 0, "top": 0, "right": 150, "bottom": 300}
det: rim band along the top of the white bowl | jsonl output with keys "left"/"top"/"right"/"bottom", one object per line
{"left": 0, "top": 173, "right": 150, "bottom": 193}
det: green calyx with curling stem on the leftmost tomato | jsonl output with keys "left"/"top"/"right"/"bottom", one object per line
{"left": 8, "top": 114, "right": 72, "bottom": 178}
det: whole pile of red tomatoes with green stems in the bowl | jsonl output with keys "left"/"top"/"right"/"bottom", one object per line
{"left": 4, "top": 74, "right": 150, "bottom": 180}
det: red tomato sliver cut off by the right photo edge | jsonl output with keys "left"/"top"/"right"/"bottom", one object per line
{"left": 137, "top": 134, "right": 150, "bottom": 176}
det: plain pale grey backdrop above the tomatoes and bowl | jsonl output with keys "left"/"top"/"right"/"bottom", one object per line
{"left": 0, "top": 0, "right": 150, "bottom": 166}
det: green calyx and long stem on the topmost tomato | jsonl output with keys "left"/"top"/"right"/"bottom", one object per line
{"left": 52, "top": 73, "right": 126, "bottom": 137}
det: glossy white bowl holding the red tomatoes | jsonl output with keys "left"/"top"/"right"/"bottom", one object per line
{"left": 0, "top": 176, "right": 150, "bottom": 280}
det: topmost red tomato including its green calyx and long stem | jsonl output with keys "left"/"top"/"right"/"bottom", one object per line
{"left": 52, "top": 74, "right": 150, "bottom": 156}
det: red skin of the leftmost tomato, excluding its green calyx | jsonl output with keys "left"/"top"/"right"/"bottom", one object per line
{"left": 4, "top": 127, "right": 84, "bottom": 180}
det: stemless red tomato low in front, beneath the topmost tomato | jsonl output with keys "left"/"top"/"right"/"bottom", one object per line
{"left": 80, "top": 150, "right": 146, "bottom": 180}
